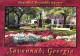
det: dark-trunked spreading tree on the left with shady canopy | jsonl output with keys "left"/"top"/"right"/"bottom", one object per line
{"left": 5, "top": 7, "right": 37, "bottom": 24}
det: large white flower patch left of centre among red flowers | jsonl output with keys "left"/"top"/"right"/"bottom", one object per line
{"left": 5, "top": 33, "right": 53, "bottom": 43}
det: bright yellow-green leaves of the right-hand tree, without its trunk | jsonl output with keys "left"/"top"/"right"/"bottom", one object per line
{"left": 51, "top": 7, "right": 76, "bottom": 19}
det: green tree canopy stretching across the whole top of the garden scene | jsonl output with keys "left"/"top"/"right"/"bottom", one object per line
{"left": 5, "top": 7, "right": 76, "bottom": 27}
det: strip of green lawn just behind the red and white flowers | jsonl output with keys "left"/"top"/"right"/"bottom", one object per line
{"left": 5, "top": 26, "right": 76, "bottom": 35}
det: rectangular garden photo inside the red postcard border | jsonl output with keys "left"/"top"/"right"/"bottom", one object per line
{"left": 4, "top": 6, "right": 76, "bottom": 47}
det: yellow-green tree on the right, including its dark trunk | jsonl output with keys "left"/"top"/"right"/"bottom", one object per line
{"left": 46, "top": 7, "right": 76, "bottom": 27}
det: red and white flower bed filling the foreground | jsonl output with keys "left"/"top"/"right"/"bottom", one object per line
{"left": 5, "top": 31, "right": 76, "bottom": 47}
